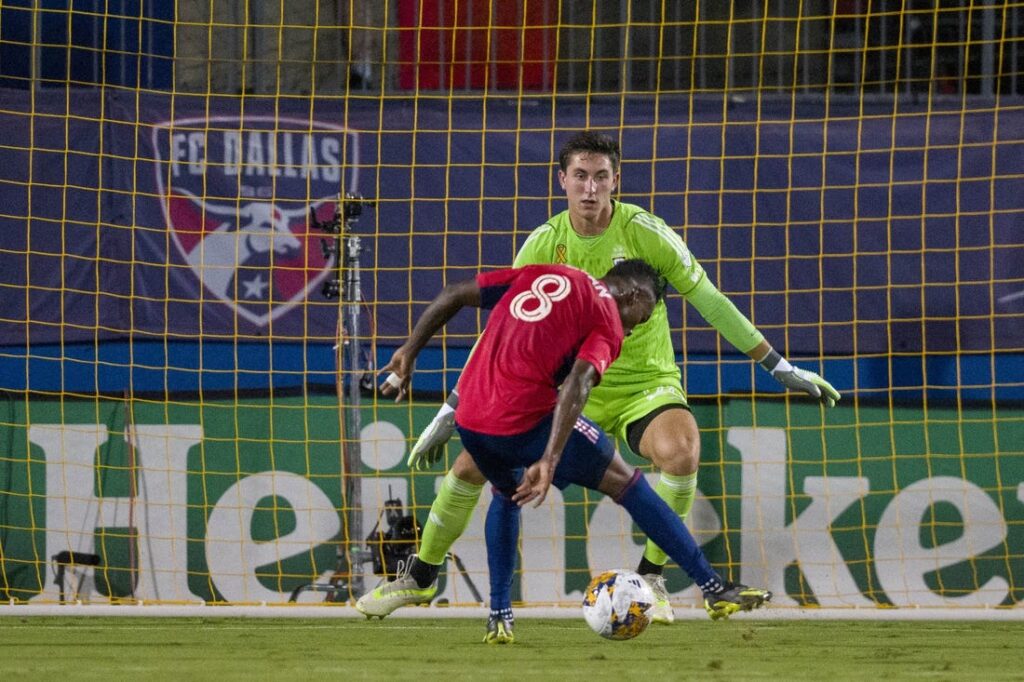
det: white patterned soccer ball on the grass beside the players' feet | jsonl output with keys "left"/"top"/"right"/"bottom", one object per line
{"left": 583, "top": 569, "right": 654, "bottom": 640}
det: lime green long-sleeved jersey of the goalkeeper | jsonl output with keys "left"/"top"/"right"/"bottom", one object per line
{"left": 513, "top": 202, "right": 764, "bottom": 390}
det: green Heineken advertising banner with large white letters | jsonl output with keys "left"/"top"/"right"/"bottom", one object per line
{"left": 0, "top": 395, "right": 1024, "bottom": 607}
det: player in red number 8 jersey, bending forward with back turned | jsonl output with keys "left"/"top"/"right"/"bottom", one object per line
{"left": 356, "top": 259, "right": 771, "bottom": 643}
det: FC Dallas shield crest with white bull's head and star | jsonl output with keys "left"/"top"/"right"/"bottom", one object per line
{"left": 153, "top": 117, "right": 358, "bottom": 327}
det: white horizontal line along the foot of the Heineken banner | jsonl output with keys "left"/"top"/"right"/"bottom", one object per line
{"left": 0, "top": 604, "right": 1024, "bottom": 622}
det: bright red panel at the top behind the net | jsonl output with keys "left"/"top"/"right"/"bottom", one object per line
{"left": 398, "top": 0, "right": 557, "bottom": 91}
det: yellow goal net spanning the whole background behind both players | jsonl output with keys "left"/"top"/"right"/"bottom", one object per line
{"left": 0, "top": 0, "right": 1024, "bottom": 617}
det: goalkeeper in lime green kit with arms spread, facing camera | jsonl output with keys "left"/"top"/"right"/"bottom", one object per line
{"left": 356, "top": 131, "right": 840, "bottom": 626}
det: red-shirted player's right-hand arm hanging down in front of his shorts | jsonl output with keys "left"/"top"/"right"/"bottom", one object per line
{"left": 512, "top": 358, "right": 600, "bottom": 507}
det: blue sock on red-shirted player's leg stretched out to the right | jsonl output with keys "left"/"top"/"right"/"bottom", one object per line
{"left": 615, "top": 470, "right": 721, "bottom": 592}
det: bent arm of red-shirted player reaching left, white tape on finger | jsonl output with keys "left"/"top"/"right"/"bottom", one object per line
{"left": 380, "top": 279, "right": 480, "bottom": 402}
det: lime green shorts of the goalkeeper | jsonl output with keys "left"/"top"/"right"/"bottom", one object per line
{"left": 583, "top": 378, "right": 689, "bottom": 450}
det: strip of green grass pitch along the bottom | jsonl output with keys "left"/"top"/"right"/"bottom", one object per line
{"left": 0, "top": 616, "right": 1024, "bottom": 682}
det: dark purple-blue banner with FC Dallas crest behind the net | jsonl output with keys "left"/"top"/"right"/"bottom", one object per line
{"left": 0, "top": 90, "right": 1024, "bottom": 356}
